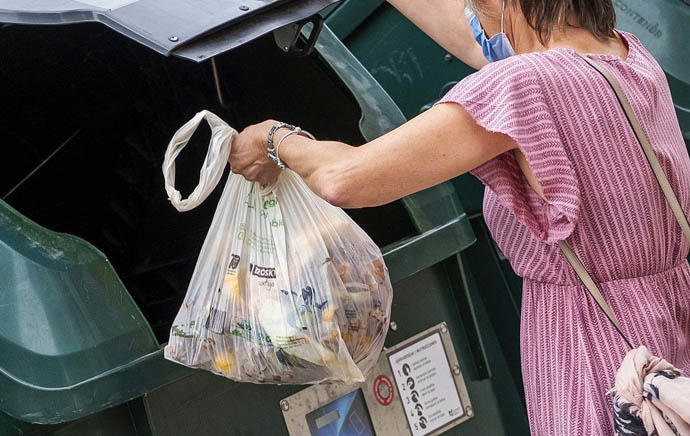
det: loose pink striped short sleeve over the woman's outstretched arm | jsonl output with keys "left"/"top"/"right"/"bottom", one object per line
{"left": 436, "top": 55, "right": 580, "bottom": 243}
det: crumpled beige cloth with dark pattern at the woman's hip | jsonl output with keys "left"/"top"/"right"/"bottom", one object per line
{"left": 613, "top": 346, "right": 690, "bottom": 436}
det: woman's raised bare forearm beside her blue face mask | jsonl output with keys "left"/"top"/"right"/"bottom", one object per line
{"left": 388, "top": 0, "right": 487, "bottom": 69}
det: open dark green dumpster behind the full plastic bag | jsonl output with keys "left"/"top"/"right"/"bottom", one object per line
{"left": 0, "top": 1, "right": 527, "bottom": 436}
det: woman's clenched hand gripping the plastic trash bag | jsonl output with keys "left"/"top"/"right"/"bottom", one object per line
{"left": 228, "top": 120, "right": 280, "bottom": 186}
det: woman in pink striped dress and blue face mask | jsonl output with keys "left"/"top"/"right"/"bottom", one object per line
{"left": 229, "top": 0, "right": 690, "bottom": 436}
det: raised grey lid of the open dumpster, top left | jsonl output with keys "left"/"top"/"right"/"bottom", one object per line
{"left": 0, "top": 0, "right": 338, "bottom": 62}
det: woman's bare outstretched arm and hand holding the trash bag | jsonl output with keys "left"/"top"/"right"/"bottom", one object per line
{"left": 230, "top": 103, "right": 517, "bottom": 208}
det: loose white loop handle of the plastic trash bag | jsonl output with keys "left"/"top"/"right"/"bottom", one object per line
{"left": 163, "top": 110, "right": 237, "bottom": 212}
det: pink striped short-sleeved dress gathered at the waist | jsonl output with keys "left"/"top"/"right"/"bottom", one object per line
{"left": 437, "top": 32, "right": 690, "bottom": 436}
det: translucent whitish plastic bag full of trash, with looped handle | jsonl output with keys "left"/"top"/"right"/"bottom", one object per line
{"left": 158, "top": 111, "right": 393, "bottom": 384}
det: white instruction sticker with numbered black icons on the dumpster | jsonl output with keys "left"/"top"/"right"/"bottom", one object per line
{"left": 388, "top": 332, "right": 465, "bottom": 436}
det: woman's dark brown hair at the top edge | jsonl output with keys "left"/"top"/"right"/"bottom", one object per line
{"left": 510, "top": 0, "right": 616, "bottom": 44}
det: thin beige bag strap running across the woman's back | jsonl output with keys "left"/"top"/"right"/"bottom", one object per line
{"left": 558, "top": 53, "right": 690, "bottom": 348}
